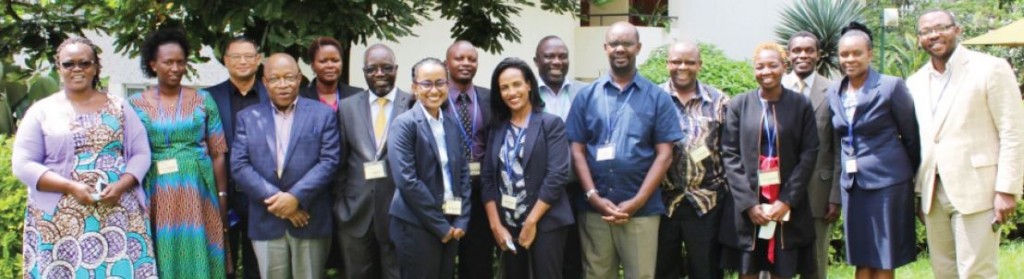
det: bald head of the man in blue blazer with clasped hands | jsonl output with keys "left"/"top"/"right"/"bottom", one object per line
{"left": 263, "top": 52, "right": 302, "bottom": 110}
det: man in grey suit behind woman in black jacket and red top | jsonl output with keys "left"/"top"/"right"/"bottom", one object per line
{"left": 782, "top": 31, "right": 840, "bottom": 278}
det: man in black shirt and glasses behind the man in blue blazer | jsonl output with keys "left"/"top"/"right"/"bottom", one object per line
{"left": 207, "top": 37, "right": 269, "bottom": 279}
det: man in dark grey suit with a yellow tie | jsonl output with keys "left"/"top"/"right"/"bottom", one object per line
{"left": 334, "top": 44, "right": 413, "bottom": 278}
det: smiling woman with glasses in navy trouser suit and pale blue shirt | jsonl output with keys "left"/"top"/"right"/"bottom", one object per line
{"left": 387, "top": 58, "right": 473, "bottom": 279}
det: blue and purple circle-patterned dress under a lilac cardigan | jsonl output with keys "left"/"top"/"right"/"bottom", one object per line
{"left": 23, "top": 97, "right": 157, "bottom": 278}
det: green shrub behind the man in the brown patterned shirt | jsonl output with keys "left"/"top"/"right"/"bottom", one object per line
{"left": 640, "top": 43, "right": 758, "bottom": 95}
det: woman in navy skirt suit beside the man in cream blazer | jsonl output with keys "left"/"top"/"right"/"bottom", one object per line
{"left": 828, "top": 23, "right": 921, "bottom": 278}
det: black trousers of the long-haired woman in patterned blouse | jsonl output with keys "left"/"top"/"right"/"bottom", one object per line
{"left": 501, "top": 227, "right": 568, "bottom": 279}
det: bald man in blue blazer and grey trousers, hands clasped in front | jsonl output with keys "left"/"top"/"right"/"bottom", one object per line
{"left": 231, "top": 53, "right": 340, "bottom": 278}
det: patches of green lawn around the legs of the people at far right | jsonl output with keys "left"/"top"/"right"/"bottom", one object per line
{"left": 828, "top": 240, "right": 1024, "bottom": 279}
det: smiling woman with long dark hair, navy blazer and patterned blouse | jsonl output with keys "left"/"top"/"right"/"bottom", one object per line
{"left": 480, "top": 57, "right": 573, "bottom": 278}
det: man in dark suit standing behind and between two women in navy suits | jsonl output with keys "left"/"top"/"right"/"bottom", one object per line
{"left": 444, "top": 41, "right": 498, "bottom": 278}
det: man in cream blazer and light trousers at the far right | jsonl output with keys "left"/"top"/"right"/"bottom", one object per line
{"left": 906, "top": 10, "right": 1024, "bottom": 278}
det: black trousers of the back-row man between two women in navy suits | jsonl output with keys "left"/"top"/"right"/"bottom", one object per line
{"left": 459, "top": 177, "right": 498, "bottom": 279}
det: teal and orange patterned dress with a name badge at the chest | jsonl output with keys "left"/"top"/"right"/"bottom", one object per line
{"left": 128, "top": 90, "right": 227, "bottom": 278}
